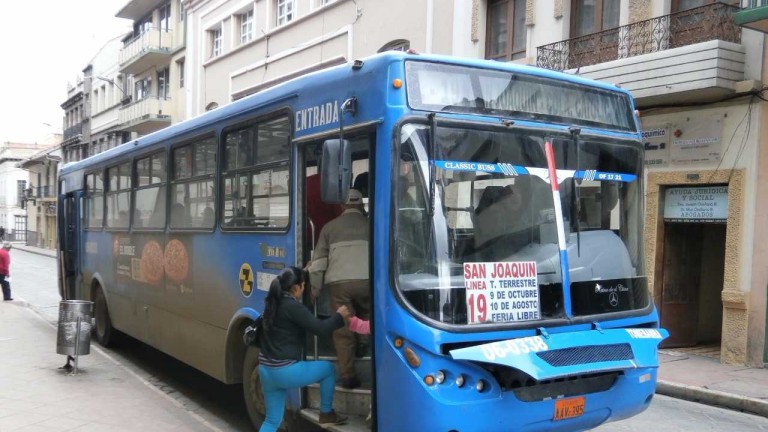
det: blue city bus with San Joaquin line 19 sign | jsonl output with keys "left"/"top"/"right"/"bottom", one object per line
{"left": 58, "top": 52, "right": 668, "bottom": 432}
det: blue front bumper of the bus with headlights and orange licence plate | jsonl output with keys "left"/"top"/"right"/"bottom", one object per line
{"left": 378, "top": 329, "right": 668, "bottom": 432}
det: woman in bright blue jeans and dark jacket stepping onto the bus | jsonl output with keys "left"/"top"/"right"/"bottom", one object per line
{"left": 259, "top": 267, "right": 350, "bottom": 432}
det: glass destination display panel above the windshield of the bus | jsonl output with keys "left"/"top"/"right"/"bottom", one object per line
{"left": 405, "top": 61, "right": 637, "bottom": 131}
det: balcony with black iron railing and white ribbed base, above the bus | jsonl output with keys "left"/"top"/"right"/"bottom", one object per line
{"left": 537, "top": 3, "right": 745, "bottom": 107}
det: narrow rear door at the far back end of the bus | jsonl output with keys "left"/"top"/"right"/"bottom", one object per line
{"left": 58, "top": 192, "right": 80, "bottom": 300}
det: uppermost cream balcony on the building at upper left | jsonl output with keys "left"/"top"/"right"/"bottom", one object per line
{"left": 120, "top": 28, "right": 175, "bottom": 74}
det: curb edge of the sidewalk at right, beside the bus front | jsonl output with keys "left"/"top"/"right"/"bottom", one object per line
{"left": 656, "top": 380, "right": 768, "bottom": 417}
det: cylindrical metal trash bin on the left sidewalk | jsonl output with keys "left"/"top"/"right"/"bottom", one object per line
{"left": 56, "top": 300, "right": 93, "bottom": 357}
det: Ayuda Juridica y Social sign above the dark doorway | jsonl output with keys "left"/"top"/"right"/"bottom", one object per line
{"left": 664, "top": 186, "right": 728, "bottom": 223}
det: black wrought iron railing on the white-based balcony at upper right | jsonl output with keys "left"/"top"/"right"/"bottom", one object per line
{"left": 536, "top": 3, "right": 741, "bottom": 70}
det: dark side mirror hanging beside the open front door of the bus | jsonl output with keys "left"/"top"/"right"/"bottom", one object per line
{"left": 320, "top": 139, "right": 352, "bottom": 204}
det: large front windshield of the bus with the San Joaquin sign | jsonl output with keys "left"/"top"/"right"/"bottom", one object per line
{"left": 395, "top": 124, "right": 649, "bottom": 325}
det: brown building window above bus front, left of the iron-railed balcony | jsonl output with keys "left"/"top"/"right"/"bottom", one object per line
{"left": 485, "top": 0, "right": 527, "bottom": 61}
